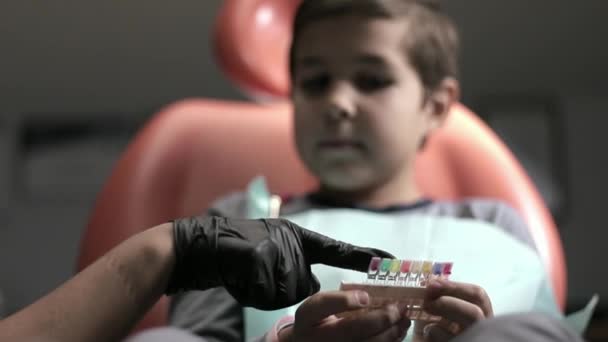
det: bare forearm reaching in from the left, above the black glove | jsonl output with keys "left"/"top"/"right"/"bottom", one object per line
{"left": 0, "top": 224, "right": 175, "bottom": 342}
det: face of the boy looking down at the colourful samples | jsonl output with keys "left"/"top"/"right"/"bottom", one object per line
{"left": 292, "top": 15, "right": 447, "bottom": 191}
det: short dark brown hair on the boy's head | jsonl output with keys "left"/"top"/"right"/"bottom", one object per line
{"left": 289, "top": 0, "right": 459, "bottom": 91}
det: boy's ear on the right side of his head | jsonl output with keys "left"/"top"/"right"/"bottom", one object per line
{"left": 429, "top": 77, "right": 460, "bottom": 131}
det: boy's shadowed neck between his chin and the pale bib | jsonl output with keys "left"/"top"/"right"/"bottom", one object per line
{"left": 318, "top": 175, "right": 422, "bottom": 209}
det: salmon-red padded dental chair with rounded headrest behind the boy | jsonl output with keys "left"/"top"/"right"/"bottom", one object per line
{"left": 78, "top": 0, "right": 566, "bottom": 331}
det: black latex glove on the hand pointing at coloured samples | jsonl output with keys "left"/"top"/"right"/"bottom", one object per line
{"left": 166, "top": 216, "right": 393, "bottom": 310}
